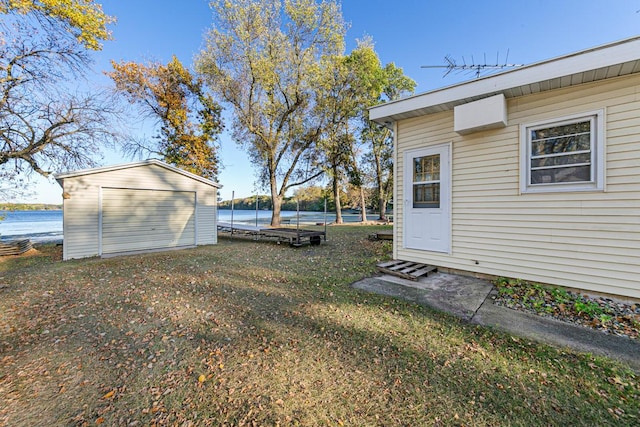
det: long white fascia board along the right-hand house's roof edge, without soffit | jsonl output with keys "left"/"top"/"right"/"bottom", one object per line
{"left": 369, "top": 37, "right": 640, "bottom": 122}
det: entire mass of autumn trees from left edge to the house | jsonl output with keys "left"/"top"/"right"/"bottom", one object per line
{"left": 0, "top": 0, "right": 415, "bottom": 225}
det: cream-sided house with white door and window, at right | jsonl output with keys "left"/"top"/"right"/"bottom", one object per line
{"left": 370, "top": 37, "right": 640, "bottom": 298}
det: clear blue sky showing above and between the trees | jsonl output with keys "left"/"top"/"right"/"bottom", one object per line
{"left": 23, "top": 0, "right": 640, "bottom": 203}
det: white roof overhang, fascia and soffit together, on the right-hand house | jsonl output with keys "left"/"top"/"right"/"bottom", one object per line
{"left": 369, "top": 36, "right": 640, "bottom": 124}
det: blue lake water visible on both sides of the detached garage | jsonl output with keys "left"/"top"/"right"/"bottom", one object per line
{"left": 0, "top": 209, "right": 360, "bottom": 242}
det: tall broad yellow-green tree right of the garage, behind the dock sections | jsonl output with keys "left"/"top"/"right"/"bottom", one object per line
{"left": 197, "top": 0, "right": 345, "bottom": 225}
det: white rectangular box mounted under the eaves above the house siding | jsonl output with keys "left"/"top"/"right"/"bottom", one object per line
{"left": 453, "top": 94, "right": 507, "bottom": 135}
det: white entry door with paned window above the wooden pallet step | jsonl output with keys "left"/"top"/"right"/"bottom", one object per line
{"left": 403, "top": 144, "right": 451, "bottom": 253}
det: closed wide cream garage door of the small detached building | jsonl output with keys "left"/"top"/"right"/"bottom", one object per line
{"left": 102, "top": 188, "right": 196, "bottom": 254}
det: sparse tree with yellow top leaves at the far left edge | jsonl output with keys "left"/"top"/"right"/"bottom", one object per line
{"left": 0, "top": 0, "right": 114, "bottom": 196}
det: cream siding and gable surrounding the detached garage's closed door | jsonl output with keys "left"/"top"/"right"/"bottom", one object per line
{"left": 63, "top": 164, "right": 217, "bottom": 259}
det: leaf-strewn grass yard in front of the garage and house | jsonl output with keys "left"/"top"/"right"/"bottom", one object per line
{"left": 0, "top": 226, "right": 640, "bottom": 426}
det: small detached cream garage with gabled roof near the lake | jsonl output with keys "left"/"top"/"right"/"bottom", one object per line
{"left": 56, "top": 160, "right": 220, "bottom": 260}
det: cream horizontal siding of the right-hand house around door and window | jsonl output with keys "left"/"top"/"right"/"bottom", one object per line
{"left": 395, "top": 75, "right": 640, "bottom": 298}
